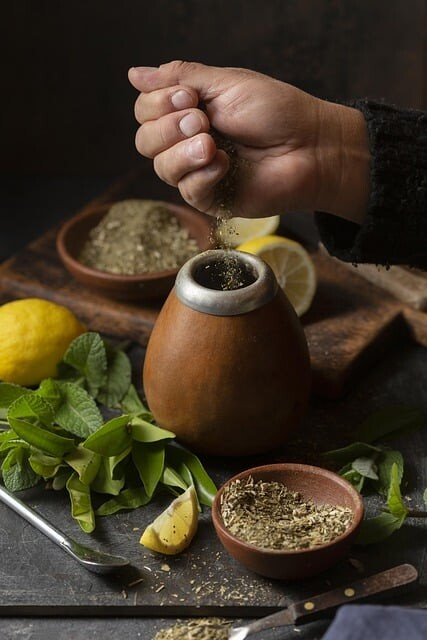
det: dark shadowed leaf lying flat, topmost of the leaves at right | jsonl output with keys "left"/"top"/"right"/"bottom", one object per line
{"left": 355, "top": 405, "right": 426, "bottom": 442}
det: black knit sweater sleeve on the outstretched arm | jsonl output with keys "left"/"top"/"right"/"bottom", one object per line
{"left": 316, "top": 100, "right": 427, "bottom": 269}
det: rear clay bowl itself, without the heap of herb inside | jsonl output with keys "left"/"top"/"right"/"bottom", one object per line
{"left": 56, "top": 201, "right": 213, "bottom": 301}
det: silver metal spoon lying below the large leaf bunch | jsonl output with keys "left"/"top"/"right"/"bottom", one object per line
{"left": 0, "top": 485, "right": 129, "bottom": 573}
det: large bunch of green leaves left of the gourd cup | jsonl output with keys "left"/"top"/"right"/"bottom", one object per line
{"left": 0, "top": 332, "right": 216, "bottom": 533}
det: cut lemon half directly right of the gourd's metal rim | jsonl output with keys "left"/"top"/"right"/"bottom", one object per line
{"left": 237, "top": 235, "right": 316, "bottom": 316}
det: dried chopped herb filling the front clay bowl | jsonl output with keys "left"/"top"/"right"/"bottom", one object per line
{"left": 221, "top": 476, "right": 353, "bottom": 550}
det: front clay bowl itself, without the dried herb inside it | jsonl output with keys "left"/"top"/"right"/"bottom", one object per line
{"left": 212, "top": 463, "right": 363, "bottom": 580}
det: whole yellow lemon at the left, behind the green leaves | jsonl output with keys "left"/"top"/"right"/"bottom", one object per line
{"left": 0, "top": 298, "right": 86, "bottom": 386}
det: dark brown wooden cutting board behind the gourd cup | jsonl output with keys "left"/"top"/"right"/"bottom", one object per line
{"left": 0, "top": 173, "right": 427, "bottom": 398}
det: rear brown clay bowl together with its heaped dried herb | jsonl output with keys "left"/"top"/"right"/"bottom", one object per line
{"left": 56, "top": 200, "right": 213, "bottom": 300}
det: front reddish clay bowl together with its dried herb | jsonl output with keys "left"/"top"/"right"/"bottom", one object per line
{"left": 212, "top": 463, "right": 363, "bottom": 580}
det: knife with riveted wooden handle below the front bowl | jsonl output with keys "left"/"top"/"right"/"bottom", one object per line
{"left": 228, "top": 564, "right": 418, "bottom": 640}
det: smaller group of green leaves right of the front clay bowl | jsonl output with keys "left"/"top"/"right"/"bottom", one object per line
{"left": 323, "top": 405, "right": 427, "bottom": 545}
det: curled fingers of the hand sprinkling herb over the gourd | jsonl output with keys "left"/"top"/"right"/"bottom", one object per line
{"left": 129, "top": 61, "right": 237, "bottom": 215}
